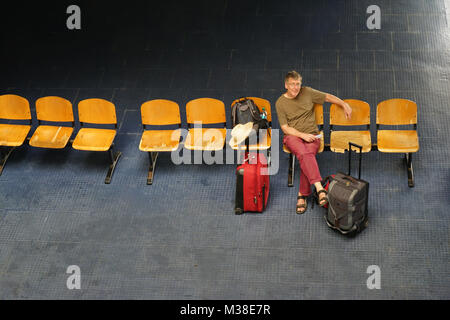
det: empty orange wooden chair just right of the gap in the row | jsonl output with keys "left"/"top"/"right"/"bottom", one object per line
{"left": 139, "top": 100, "right": 181, "bottom": 185}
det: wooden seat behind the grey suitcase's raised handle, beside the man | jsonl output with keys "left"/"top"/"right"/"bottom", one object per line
{"left": 330, "top": 131, "right": 372, "bottom": 153}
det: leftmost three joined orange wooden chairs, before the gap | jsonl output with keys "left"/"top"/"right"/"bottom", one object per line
{"left": 0, "top": 94, "right": 121, "bottom": 184}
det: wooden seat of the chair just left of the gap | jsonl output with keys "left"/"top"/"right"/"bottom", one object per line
{"left": 72, "top": 128, "right": 116, "bottom": 151}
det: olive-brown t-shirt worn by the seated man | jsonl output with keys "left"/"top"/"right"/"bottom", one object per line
{"left": 275, "top": 87, "right": 326, "bottom": 134}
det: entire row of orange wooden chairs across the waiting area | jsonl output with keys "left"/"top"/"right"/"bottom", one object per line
{"left": 0, "top": 95, "right": 419, "bottom": 187}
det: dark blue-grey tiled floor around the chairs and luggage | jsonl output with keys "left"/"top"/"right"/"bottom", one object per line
{"left": 0, "top": 0, "right": 450, "bottom": 299}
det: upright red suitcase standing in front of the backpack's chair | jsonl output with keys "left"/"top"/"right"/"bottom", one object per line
{"left": 234, "top": 152, "right": 270, "bottom": 214}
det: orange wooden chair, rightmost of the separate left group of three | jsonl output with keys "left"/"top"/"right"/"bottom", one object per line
{"left": 72, "top": 99, "right": 122, "bottom": 184}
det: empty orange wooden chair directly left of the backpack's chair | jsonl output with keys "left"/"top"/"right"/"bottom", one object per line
{"left": 184, "top": 98, "right": 227, "bottom": 151}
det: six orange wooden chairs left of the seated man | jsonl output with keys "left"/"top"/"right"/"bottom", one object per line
{"left": 0, "top": 95, "right": 272, "bottom": 184}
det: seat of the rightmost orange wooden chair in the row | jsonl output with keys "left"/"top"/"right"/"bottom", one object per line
{"left": 377, "top": 130, "right": 419, "bottom": 153}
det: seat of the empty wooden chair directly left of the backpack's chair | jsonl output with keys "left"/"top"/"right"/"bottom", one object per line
{"left": 184, "top": 128, "right": 227, "bottom": 151}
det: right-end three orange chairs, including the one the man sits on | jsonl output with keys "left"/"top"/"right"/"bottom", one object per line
{"left": 283, "top": 99, "right": 419, "bottom": 187}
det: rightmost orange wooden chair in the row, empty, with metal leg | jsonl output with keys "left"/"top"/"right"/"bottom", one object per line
{"left": 377, "top": 99, "right": 419, "bottom": 187}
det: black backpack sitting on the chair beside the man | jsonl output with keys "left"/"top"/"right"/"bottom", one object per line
{"left": 231, "top": 98, "right": 269, "bottom": 133}
